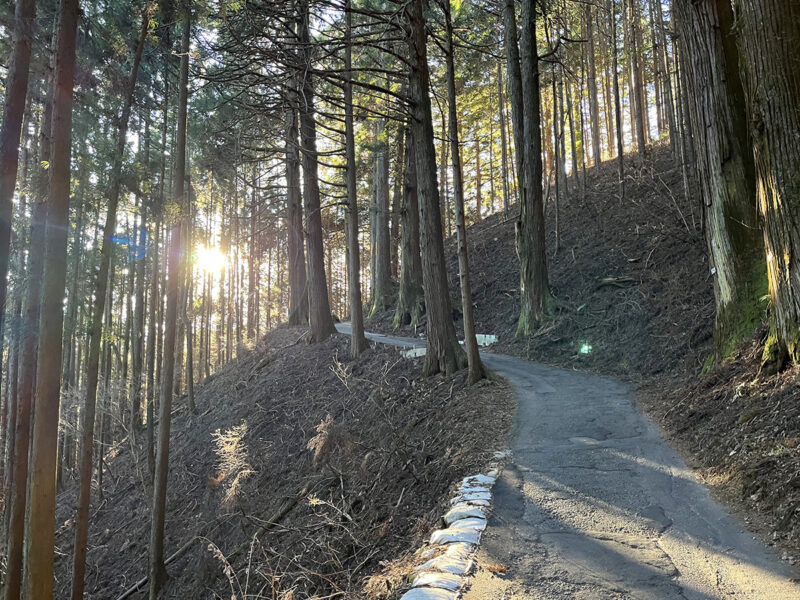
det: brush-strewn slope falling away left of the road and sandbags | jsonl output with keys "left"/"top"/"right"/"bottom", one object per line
{"left": 50, "top": 327, "right": 514, "bottom": 600}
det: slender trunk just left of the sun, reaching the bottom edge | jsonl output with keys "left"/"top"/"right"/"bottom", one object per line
{"left": 148, "top": 5, "right": 192, "bottom": 600}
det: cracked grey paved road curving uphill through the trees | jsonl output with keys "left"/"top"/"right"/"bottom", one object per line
{"left": 337, "top": 324, "right": 800, "bottom": 600}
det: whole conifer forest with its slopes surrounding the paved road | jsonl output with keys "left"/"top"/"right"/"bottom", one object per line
{"left": 0, "top": 0, "right": 800, "bottom": 600}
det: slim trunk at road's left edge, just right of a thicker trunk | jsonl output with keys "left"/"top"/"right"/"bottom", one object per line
{"left": 444, "top": 2, "right": 486, "bottom": 384}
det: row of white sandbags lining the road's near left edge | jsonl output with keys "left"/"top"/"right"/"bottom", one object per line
{"left": 400, "top": 450, "right": 511, "bottom": 600}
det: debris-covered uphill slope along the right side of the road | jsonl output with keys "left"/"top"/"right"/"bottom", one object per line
{"left": 367, "top": 147, "right": 800, "bottom": 563}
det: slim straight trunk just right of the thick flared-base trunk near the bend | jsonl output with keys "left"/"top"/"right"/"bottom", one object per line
{"left": 344, "top": 0, "right": 367, "bottom": 358}
